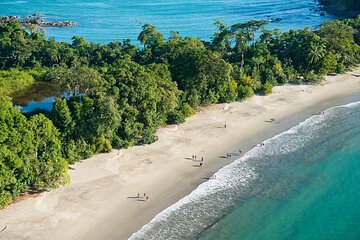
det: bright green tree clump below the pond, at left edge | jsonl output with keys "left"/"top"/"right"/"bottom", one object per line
{"left": 0, "top": 98, "right": 69, "bottom": 207}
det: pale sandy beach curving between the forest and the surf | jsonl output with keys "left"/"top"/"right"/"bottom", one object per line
{"left": 0, "top": 69, "right": 360, "bottom": 240}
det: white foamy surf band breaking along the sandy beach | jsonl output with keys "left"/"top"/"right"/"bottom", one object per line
{"left": 130, "top": 102, "right": 360, "bottom": 240}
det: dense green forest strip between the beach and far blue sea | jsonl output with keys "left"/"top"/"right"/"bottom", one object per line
{"left": 0, "top": 17, "right": 360, "bottom": 208}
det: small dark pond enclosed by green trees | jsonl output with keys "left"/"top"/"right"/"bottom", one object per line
{"left": 11, "top": 82, "right": 64, "bottom": 112}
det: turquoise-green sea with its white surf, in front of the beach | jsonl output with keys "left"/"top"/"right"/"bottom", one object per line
{"left": 131, "top": 102, "right": 360, "bottom": 240}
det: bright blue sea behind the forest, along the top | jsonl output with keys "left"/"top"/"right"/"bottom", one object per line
{"left": 0, "top": 0, "right": 332, "bottom": 42}
